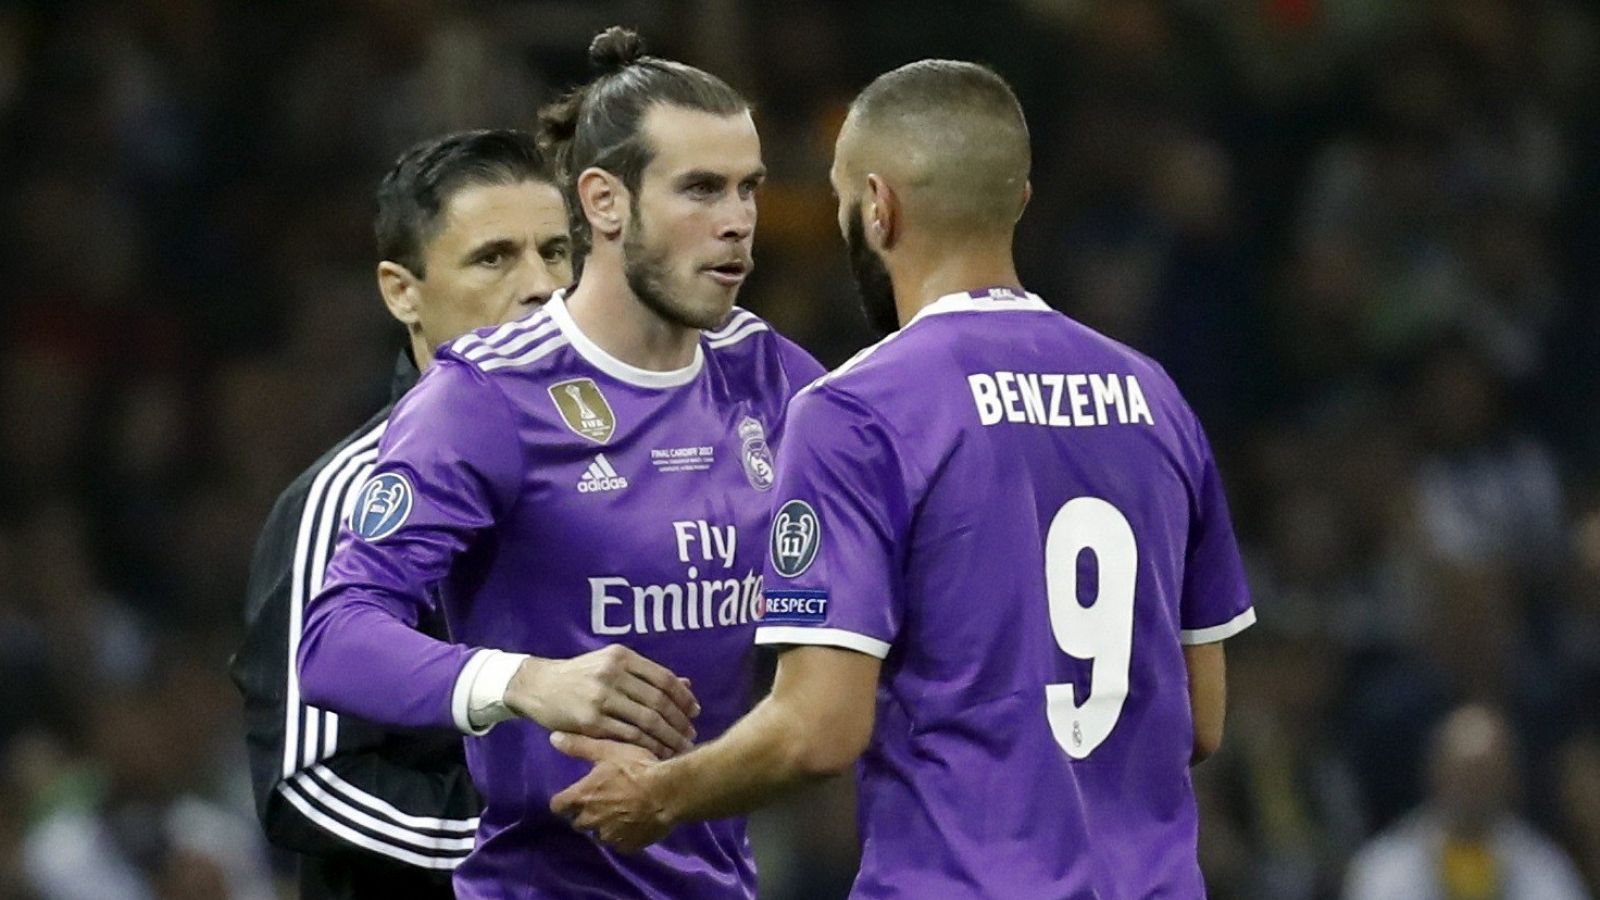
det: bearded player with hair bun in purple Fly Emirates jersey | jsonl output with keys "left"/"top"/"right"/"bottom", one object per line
{"left": 299, "top": 29, "right": 821, "bottom": 900}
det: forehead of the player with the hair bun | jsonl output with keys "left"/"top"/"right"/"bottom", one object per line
{"left": 642, "top": 104, "right": 762, "bottom": 179}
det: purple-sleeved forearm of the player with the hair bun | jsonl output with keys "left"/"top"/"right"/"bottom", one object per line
{"left": 298, "top": 593, "right": 474, "bottom": 729}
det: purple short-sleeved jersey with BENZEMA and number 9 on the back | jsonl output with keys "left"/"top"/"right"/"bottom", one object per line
{"left": 755, "top": 290, "right": 1254, "bottom": 900}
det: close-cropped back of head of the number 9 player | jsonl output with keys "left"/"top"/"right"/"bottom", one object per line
{"left": 838, "top": 59, "right": 1032, "bottom": 231}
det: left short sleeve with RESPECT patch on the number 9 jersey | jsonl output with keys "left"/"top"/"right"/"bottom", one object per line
{"left": 755, "top": 386, "right": 907, "bottom": 658}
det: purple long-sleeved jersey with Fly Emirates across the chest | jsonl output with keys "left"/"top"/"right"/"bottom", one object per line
{"left": 299, "top": 296, "right": 822, "bottom": 900}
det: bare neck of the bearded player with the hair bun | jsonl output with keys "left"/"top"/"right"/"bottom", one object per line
{"left": 566, "top": 247, "right": 699, "bottom": 372}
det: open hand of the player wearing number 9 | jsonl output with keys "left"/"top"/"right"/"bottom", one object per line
{"left": 550, "top": 732, "right": 672, "bottom": 854}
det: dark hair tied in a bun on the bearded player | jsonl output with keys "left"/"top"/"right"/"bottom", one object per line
{"left": 539, "top": 26, "right": 750, "bottom": 219}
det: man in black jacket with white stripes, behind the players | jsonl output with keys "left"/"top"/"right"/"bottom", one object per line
{"left": 232, "top": 131, "right": 576, "bottom": 898}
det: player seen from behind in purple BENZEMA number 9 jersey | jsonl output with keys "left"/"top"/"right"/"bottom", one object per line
{"left": 554, "top": 61, "right": 1254, "bottom": 900}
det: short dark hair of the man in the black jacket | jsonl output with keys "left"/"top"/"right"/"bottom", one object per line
{"left": 373, "top": 130, "right": 560, "bottom": 279}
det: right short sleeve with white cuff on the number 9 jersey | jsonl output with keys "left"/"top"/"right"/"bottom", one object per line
{"left": 1179, "top": 422, "right": 1256, "bottom": 645}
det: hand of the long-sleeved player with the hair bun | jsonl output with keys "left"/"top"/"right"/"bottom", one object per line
{"left": 506, "top": 644, "right": 699, "bottom": 759}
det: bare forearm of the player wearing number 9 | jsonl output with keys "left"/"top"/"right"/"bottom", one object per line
{"left": 650, "top": 685, "right": 834, "bottom": 825}
